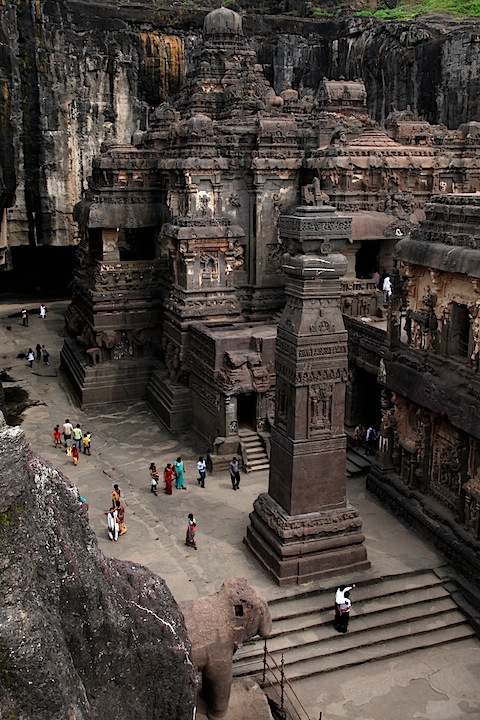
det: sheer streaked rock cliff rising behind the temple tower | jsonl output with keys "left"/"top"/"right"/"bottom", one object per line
{"left": 0, "top": 0, "right": 480, "bottom": 253}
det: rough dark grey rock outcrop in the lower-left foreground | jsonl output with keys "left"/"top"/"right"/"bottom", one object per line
{"left": 0, "top": 420, "right": 196, "bottom": 720}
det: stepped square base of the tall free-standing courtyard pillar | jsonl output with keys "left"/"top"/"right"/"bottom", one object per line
{"left": 244, "top": 493, "right": 370, "bottom": 586}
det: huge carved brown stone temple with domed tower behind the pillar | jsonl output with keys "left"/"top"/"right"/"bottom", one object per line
{"left": 53, "top": 8, "right": 480, "bottom": 575}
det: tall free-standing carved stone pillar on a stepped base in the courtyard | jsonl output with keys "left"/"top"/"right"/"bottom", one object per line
{"left": 245, "top": 205, "right": 370, "bottom": 585}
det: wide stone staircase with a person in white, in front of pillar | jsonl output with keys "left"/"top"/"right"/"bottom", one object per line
{"left": 233, "top": 570, "right": 475, "bottom": 684}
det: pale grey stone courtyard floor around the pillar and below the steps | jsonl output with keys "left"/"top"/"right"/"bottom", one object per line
{"left": 0, "top": 301, "right": 480, "bottom": 720}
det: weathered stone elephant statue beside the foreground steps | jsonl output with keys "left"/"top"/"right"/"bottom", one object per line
{"left": 179, "top": 578, "right": 272, "bottom": 720}
